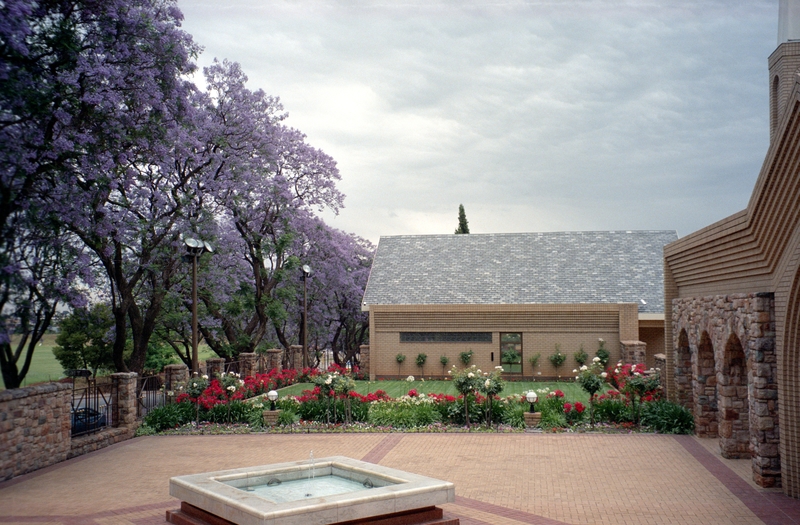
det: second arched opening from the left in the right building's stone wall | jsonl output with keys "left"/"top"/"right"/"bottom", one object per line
{"left": 692, "top": 330, "right": 719, "bottom": 438}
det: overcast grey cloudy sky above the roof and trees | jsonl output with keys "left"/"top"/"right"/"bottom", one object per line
{"left": 178, "top": 0, "right": 778, "bottom": 242}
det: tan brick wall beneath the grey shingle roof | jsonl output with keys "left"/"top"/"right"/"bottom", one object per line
{"left": 370, "top": 304, "right": 639, "bottom": 378}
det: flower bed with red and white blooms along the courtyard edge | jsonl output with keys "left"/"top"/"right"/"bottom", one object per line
{"left": 140, "top": 358, "right": 693, "bottom": 433}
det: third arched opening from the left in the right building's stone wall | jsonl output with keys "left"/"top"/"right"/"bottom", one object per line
{"left": 717, "top": 334, "right": 750, "bottom": 459}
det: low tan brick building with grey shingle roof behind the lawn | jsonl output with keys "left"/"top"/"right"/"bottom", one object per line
{"left": 362, "top": 231, "right": 677, "bottom": 379}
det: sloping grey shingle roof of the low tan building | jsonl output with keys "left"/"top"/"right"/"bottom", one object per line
{"left": 364, "top": 231, "right": 678, "bottom": 313}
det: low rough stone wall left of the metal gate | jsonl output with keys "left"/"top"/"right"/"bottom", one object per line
{"left": 0, "top": 383, "right": 72, "bottom": 480}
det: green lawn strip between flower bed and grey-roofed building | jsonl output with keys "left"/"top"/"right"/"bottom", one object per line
{"left": 280, "top": 381, "right": 589, "bottom": 403}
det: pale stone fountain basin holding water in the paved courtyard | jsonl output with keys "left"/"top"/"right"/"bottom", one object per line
{"left": 169, "top": 456, "right": 455, "bottom": 525}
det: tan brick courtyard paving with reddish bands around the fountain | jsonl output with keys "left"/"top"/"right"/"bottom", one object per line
{"left": 0, "top": 434, "right": 800, "bottom": 525}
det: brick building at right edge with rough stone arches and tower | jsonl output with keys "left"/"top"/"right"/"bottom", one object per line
{"left": 664, "top": 0, "right": 800, "bottom": 497}
